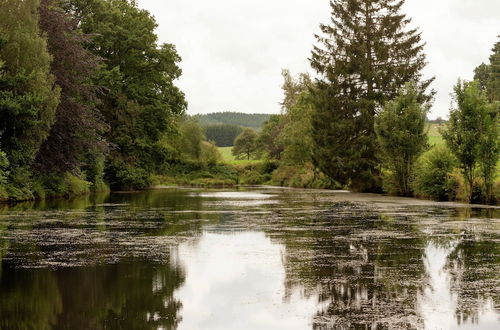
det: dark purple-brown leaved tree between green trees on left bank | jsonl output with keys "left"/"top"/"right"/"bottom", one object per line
{"left": 36, "top": 0, "right": 107, "bottom": 173}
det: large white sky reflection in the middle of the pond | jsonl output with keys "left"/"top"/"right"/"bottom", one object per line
{"left": 175, "top": 232, "right": 317, "bottom": 330}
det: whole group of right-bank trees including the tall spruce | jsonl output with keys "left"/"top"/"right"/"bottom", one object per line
{"left": 236, "top": 0, "right": 500, "bottom": 203}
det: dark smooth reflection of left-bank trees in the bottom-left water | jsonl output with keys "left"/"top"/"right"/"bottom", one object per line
{"left": 0, "top": 251, "right": 185, "bottom": 329}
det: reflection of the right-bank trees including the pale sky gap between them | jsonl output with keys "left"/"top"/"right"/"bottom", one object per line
{"left": 270, "top": 203, "right": 500, "bottom": 329}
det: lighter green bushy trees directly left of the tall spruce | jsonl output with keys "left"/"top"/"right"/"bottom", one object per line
{"left": 242, "top": 70, "right": 337, "bottom": 188}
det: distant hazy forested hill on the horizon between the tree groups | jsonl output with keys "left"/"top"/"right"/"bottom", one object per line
{"left": 193, "top": 112, "right": 271, "bottom": 147}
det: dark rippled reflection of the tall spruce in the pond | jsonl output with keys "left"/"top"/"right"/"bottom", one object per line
{"left": 276, "top": 203, "right": 425, "bottom": 329}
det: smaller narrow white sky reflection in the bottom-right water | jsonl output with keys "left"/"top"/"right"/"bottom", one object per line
{"left": 419, "top": 241, "right": 498, "bottom": 330}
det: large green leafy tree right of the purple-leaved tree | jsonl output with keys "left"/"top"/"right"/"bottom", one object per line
{"left": 71, "top": 0, "right": 186, "bottom": 189}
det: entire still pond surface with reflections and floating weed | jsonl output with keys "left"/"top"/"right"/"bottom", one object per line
{"left": 0, "top": 187, "right": 500, "bottom": 330}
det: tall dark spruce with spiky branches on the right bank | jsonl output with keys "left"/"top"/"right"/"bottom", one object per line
{"left": 311, "top": 0, "right": 433, "bottom": 191}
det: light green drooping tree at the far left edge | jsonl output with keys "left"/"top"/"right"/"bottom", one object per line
{"left": 0, "top": 0, "right": 60, "bottom": 198}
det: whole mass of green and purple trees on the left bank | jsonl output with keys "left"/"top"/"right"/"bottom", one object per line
{"left": 0, "top": 0, "right": 225, "bottom": 200}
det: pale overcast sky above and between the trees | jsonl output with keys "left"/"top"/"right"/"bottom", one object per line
{"left": 138, "top": 0, "right": 500, "bottom": 118}
